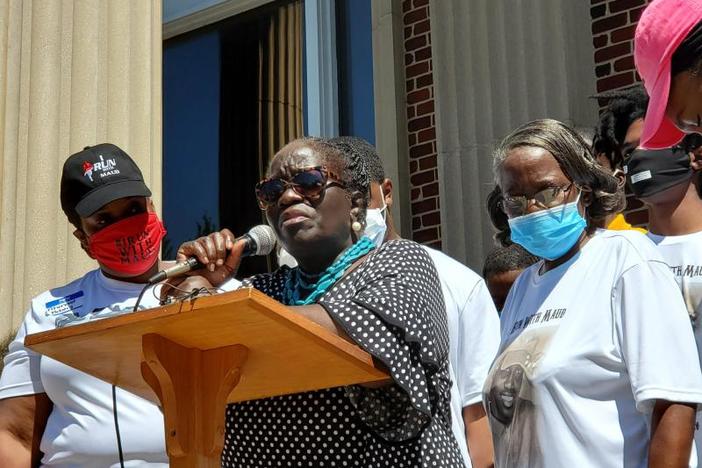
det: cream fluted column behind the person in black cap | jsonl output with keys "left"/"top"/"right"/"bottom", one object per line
{"left": 0, "top": 0, "right": 162, "bottom": 337}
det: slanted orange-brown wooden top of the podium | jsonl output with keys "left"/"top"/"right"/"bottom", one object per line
{"left": 25, "top": 288, "right": 388, "bottom": 403}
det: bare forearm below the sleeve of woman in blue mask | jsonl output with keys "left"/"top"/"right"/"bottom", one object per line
{"left": 648, "top": 400, "right": 697, "bottom": 468}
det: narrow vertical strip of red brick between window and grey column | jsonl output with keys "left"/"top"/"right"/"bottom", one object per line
{"left": 402, "top": 0, "right": 441, "bottom": 248}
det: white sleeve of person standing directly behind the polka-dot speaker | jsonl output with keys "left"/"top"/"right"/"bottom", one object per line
{"left": 456, "top": 280, "right": 500, "bottom": 408}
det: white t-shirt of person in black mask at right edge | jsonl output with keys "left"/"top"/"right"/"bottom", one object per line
{"left": 648, "top": 232, "right": 702, "bottom": 468}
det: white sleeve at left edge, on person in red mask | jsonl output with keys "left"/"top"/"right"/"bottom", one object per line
{"left": 0, "top": 309, "right": 44, "bottom": 400}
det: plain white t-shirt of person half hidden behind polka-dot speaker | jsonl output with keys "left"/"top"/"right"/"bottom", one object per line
{"left": 425, "top": 247, "right": 500, "bottom": 468}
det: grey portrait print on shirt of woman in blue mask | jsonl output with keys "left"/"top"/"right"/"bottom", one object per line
{"left": 485, "top": 326, "right": 564, "bottom": 466}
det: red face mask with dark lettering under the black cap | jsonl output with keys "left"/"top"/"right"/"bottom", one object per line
{"left": 88, "top": 212, "right": 166, "bottom": 276}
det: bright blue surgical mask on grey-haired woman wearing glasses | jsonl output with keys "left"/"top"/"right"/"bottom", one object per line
{"left": 509, "top": 194, "right": 587, "bottom": 260}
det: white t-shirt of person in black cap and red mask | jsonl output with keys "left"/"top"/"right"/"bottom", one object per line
{"left": 0, "top": 269, "right": 168, "bottom": 468}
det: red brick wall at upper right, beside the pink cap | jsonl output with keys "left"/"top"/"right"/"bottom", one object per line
{"left": 590, "top": 0, "right": 651, "bottom": 225}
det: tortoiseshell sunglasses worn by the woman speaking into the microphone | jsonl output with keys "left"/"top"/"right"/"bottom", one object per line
{"left": 256, "top": 166, "right": 345, "bottom": 210}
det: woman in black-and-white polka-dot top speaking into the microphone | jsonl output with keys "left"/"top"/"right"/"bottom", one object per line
{"left": 179, "top": 139, "right": 463, "bottom": 468}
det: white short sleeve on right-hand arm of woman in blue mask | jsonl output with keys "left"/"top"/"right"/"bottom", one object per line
{"left": 612, "top": 261, "right": 702, "bottom": 412}
